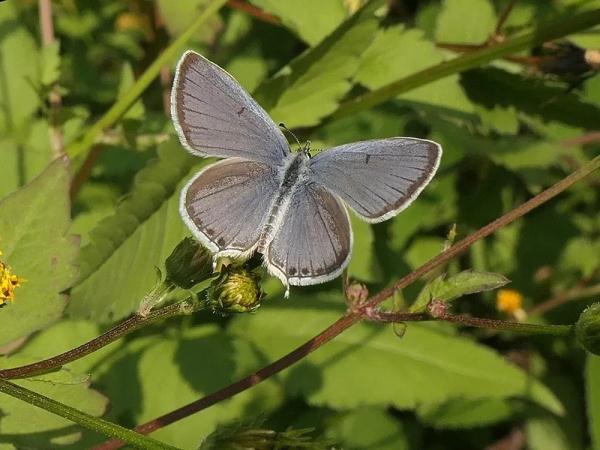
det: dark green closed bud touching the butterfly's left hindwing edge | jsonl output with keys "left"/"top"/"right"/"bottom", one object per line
{"left": 165, "top": 237, "right": 212, "bottom": 289}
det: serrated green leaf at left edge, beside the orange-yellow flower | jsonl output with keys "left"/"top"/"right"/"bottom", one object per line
{"left": 0, "top": 158, "right": 79, "bottom": 345}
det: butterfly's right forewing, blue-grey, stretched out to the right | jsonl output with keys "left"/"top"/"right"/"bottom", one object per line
{"left": 310, "top": 137, "right": 442, "bottom": 223}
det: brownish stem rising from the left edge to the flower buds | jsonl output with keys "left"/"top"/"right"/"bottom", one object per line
{"left": 0, "top": 299, "right": 202, "bottom": 380}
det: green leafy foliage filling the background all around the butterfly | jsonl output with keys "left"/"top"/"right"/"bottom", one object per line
{"left": 0, "top": 0, "right": 600, "bottom": 450}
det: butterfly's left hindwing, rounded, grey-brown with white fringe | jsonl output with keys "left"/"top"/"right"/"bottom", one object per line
{"left": 180, "top": 158, "right": 280, "bottom": 258}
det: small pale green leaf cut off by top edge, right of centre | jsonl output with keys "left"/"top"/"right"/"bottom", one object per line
{"left": 435, "top": 0, "right": 496, "bottom": 44}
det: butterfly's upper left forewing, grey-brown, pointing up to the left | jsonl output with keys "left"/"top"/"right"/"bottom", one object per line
{"left": 171, "top": 51, "right": 289, "bottom": 166}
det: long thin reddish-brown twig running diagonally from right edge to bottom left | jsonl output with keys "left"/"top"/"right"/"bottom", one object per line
{"left": 94, "top": 156, "right": 600, "bottom": 450}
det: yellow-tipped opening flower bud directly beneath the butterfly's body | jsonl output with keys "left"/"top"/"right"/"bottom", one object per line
{"left": 208, "top": 266, "right": 263, "bottom": 314}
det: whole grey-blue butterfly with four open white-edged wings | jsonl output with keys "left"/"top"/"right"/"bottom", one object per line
{"left": 171, "top": 51, "right": 442, "bottom": 295}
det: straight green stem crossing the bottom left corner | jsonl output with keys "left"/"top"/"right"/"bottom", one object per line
{"left": 0, "top": 379, "right": 177, "bottom": 450}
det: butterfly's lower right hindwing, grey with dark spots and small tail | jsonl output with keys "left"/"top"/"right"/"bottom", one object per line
{"left": 265, "top": 182, "right": 352, "bottom": 286}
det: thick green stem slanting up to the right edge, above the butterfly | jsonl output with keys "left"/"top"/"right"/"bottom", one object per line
{"left": 330, "top": 9, "right": 600, "bottom": 119}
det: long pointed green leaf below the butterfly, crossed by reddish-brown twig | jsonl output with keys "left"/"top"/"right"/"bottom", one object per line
{"left": 230, "top": 294, "right": 562, "bottom": 413}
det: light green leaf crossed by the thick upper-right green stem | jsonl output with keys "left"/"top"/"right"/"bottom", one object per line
{"left": 355, "top": 25, "right": 474, "bottom": 117}
